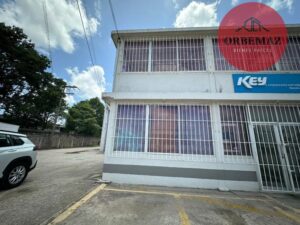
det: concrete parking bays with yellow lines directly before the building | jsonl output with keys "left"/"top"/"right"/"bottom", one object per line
{"left": 54, "top": 184, "right": 300, "bottom": 225}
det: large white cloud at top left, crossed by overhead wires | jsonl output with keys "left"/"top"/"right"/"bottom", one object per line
{"left": 0, "top": 0, "right": 100, "bottom": 53}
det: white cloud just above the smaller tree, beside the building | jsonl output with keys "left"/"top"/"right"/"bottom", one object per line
{"left": 67, "top": 65, "right": 105, "bottom": 100}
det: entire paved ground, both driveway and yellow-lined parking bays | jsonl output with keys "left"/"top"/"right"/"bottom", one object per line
{"left": 0, "top": 149, "right": 300, "bottom": 225}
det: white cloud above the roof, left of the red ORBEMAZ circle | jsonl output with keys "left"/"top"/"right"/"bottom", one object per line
{"left": 174, "top": 1, "right": 219, "bottom": 27}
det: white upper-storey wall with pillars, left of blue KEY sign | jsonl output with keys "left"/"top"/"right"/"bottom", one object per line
{"left": 113, "top": 36, "right": 300, "bottom": 100}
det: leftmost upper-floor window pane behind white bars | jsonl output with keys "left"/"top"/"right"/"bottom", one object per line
{"left": 122, "top": 41, "right": 149, "bottom": 72}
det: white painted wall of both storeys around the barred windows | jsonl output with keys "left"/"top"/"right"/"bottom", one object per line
{"left": 103, "top": 29, "right": 300, "bottom": 191}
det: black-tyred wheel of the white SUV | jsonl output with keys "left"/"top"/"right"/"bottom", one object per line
{"left": 3, "top": 162, "right": 28, "bottom": 188}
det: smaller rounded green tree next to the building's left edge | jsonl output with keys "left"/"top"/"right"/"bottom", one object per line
{"left": 66, "top": 98, "right": 104, "bottom": 137}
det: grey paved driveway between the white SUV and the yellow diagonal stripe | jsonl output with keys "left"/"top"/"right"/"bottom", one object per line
{"left": 0, "top": 148, "right": 103, "bottom": 225}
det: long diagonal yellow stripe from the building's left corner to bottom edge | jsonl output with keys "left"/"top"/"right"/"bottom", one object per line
{"left": 48, "top": 184, "right": 106, "bottom": 225}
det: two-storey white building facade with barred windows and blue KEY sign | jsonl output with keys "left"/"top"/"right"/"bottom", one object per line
{"left": 101, "top": 25, "right": 300, "bottom": 192}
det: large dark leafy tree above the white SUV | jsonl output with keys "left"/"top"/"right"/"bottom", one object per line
{"left": 0, "top": 23, "right": 66, "bottom": 128}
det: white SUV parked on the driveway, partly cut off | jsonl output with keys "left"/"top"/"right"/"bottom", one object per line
{"left": 0, "top": 131, "right": 37, "bottom": 188}
